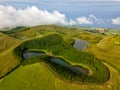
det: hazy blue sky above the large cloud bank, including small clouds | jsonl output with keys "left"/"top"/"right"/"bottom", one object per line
{"left": 0, "top": 0, "right": 120, "bottom": 27}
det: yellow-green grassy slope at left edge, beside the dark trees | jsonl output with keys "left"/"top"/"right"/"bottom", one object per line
{"left": 0, "top": 35, "right": 21, "bottom": 77}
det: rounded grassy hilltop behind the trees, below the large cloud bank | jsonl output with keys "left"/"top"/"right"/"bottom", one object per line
{"left": 17, "top": 25, "right": 73, "bottom": 38}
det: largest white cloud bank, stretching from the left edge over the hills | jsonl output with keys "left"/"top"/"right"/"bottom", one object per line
{"left": 0, "top": 5, "right": 75, "bottom": 28}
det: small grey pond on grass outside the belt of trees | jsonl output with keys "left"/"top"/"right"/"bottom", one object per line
{"left": 73, "top": 39, "right": 89, "bottom": 50}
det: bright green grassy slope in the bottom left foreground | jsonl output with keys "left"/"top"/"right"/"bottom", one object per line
{"left": 0, "top": 63, "right": 55, "bottom": 90}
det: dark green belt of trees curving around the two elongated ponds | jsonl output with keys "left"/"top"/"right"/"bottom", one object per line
{"left": 14, "top": 34, "right": 110, "bottom": 83}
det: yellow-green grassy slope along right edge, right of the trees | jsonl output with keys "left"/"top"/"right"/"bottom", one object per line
{"left": 86, "top": 36, "right": 120, "bottom": 90}
